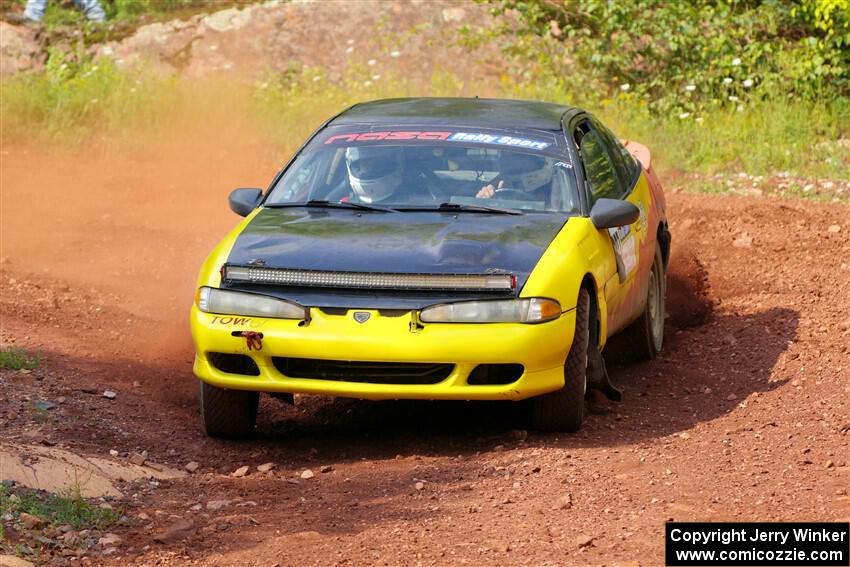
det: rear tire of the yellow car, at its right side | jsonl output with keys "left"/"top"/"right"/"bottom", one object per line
{"left": 618, "top": 244, "right": 667, "bottom": 360}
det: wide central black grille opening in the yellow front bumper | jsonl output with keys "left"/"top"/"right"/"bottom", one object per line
{"left": 272, "top": 356, "right": 454, "bottom": 384}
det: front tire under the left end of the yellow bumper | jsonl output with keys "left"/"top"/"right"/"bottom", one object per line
{"left": 201, "top": 381, "right": 260, "bottom": 439}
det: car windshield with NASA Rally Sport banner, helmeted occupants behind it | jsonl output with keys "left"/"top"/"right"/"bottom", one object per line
{"left": 264, "top": 126, "right": 579, "bottom": 213}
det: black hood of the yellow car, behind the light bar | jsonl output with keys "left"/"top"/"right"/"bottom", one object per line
{"left": 228, "top": 207, "right": 569, "bottom": 308}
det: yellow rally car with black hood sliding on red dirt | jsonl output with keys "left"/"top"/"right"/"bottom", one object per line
{"left": 191, "top": 98, "right": 670, "bottom": 437}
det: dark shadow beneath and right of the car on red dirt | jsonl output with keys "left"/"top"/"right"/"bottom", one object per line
{"left": 250, "top": 309, "right": 799, "bottom": 458}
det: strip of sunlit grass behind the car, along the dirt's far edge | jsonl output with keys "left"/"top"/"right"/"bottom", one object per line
{"left": 0, "top": 51, "right": 850, "bottom": 201}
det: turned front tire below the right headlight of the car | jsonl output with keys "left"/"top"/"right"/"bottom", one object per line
{"left": 531, "top": 288, "right": 590, "bottom": 432}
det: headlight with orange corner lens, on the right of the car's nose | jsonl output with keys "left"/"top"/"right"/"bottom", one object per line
{"left": 419, "top": 297, "right": 561, "bottom": 323}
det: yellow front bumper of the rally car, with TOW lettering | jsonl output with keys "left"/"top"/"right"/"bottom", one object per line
{"left": 191, "top": 306, "right": 575, "bottom": 400}
